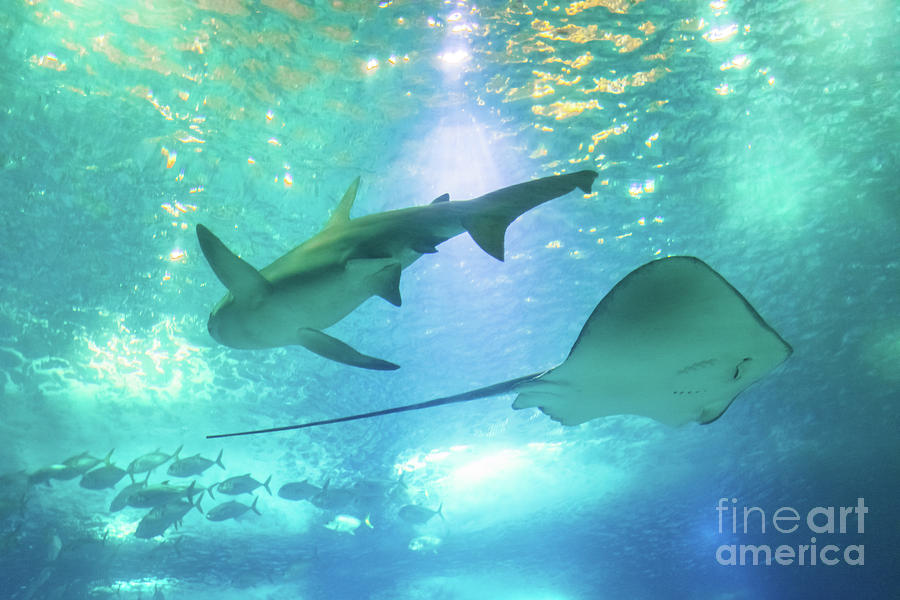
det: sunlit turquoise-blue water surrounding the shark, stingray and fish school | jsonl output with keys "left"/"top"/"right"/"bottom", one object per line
{"left": 0, "top": 0, "right": 900, "bottom": 600}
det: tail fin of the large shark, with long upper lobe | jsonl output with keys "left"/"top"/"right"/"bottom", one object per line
{"left": 462, "top": 171, "right": 597, "bottom": 260}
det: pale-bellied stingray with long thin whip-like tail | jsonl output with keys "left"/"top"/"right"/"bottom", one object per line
{"left": 207, "top": 256, "right": 792, "bottom": 438}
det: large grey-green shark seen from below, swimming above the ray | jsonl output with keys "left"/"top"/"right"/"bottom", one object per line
{"left": 197, "top": 171, "right": 597, "bottom": 370}
